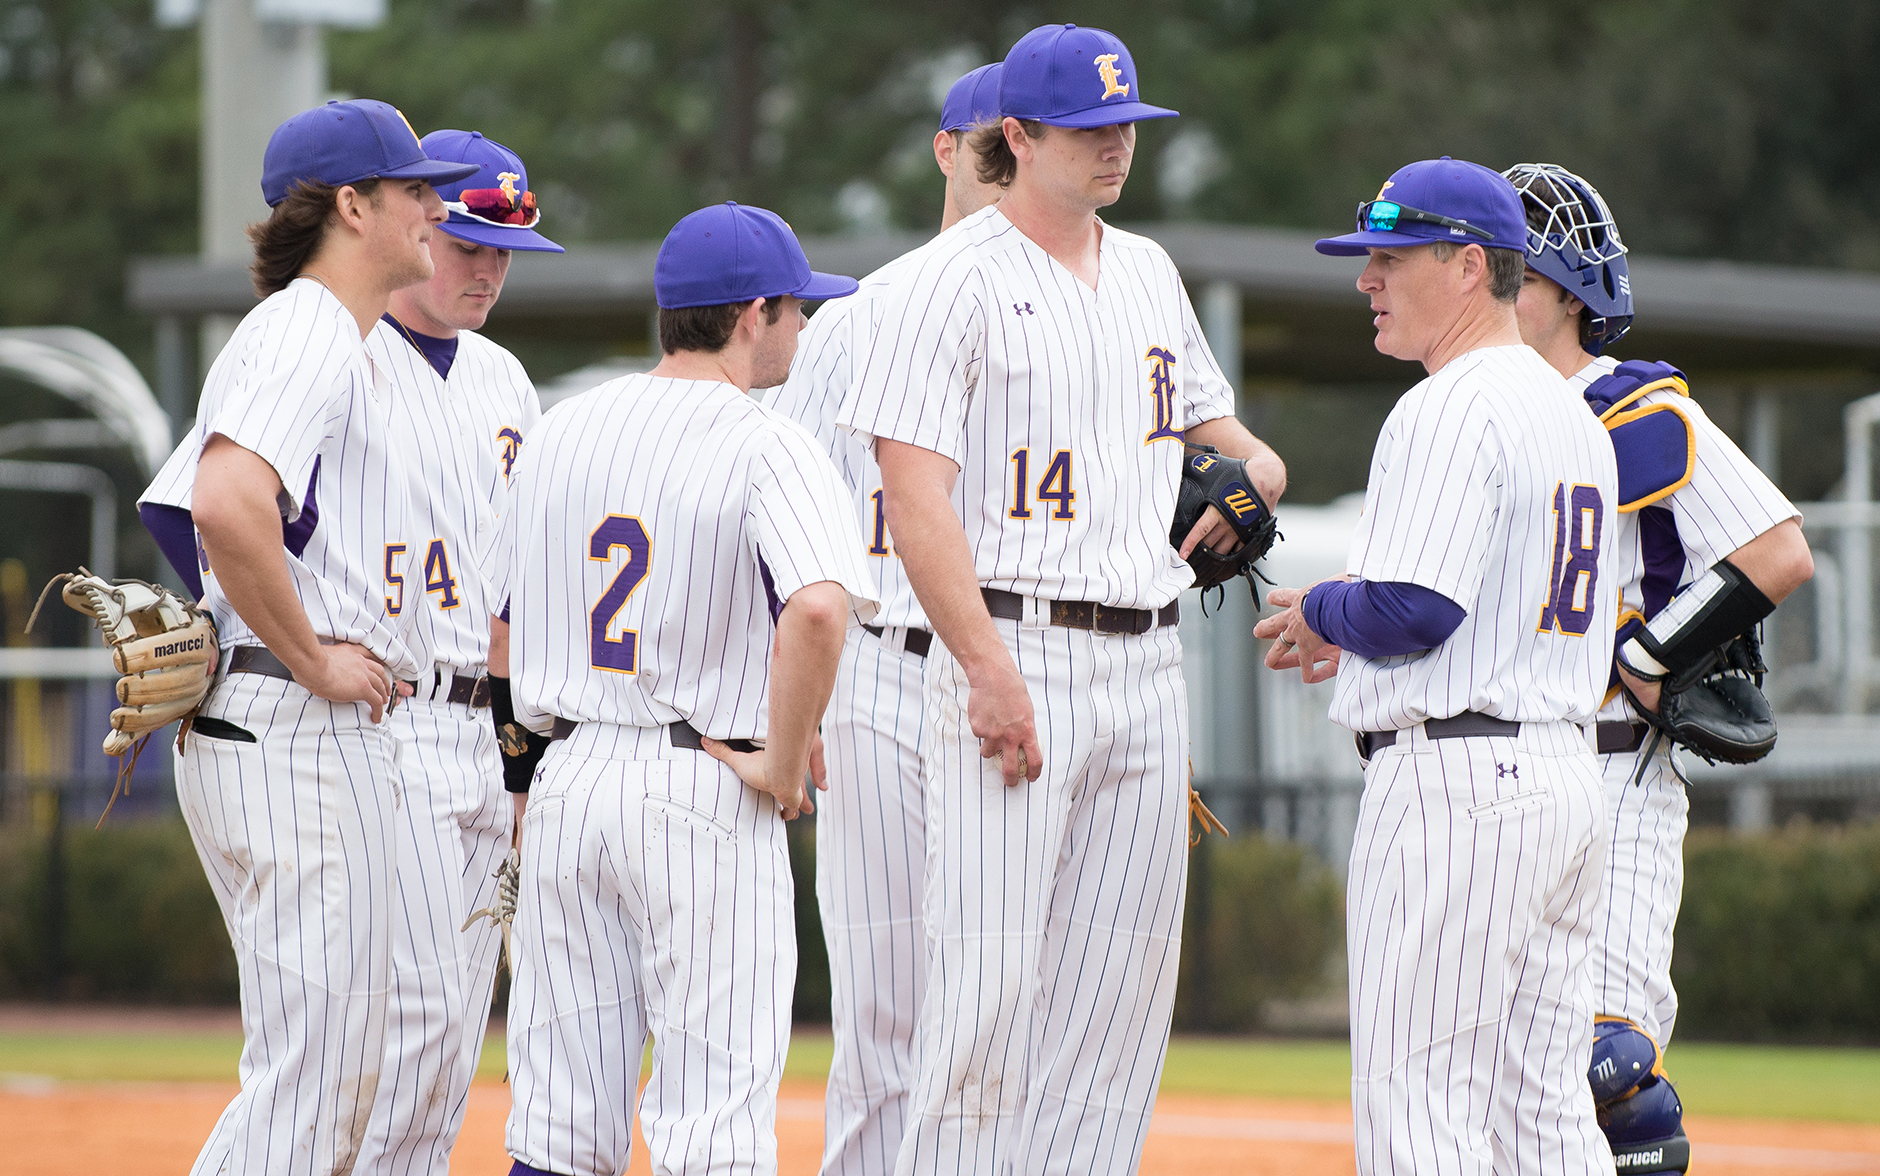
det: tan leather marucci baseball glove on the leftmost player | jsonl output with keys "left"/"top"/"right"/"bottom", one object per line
{"left": 26, "top": 567, "right": 218, "bottom": 825}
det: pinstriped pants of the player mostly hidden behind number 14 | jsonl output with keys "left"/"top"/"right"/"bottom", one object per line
{"left": 816, "top": 627, "right": 927, "bottom": 1176}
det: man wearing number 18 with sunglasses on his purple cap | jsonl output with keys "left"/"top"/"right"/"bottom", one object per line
{"left": 1256, "top": 158, "right": 1617, "bottom": 1176}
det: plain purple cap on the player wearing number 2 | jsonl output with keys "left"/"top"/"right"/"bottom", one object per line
{"left": 652, "top": 201, "right": 861, "bottom": 310}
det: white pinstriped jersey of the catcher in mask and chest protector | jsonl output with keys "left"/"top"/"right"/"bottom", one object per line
{"left": 1568, "top": 355, "right": 1801, "bottom": 721}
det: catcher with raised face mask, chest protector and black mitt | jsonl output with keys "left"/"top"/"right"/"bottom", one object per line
{"left": 1506, "top": 163, "right": 1814, "bottom": 1172}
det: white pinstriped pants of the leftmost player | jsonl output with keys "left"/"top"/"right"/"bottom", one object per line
{"left": 177, "top": 674, "right": 399, "bottom": 1176}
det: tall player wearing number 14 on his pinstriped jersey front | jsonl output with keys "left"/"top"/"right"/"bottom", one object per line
{"left": 837, "top": 24, "right": 1284, "bottom": 1172}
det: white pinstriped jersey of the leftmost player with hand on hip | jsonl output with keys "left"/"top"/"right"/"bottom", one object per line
{"left": 139, "top": 278, "right": 432, "bottom": 678}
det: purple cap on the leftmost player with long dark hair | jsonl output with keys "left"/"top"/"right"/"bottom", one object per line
{"left": 261, "top": 98, "right": 476, "bottom": 209}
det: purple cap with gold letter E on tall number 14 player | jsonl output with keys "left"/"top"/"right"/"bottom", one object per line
{"left": 998, "top": 24, "right": 1177, "bottom": 128}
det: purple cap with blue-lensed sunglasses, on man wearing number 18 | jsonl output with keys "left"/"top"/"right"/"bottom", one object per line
{"left": 1312, "top": 156, "right": 1527, "bottom": 257}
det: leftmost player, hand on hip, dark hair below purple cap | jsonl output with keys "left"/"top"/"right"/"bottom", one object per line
{"left": 140, "top": 100, "right": 476, "bottom": 1176}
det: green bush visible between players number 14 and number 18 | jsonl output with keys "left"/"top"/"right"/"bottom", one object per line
{"left": 1175, "top": 832, "right": 1344, "bottom": 1033}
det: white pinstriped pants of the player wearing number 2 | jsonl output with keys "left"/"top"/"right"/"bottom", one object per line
{"left": 504, "top": 723, "right": 797, "bottom": 1176}
